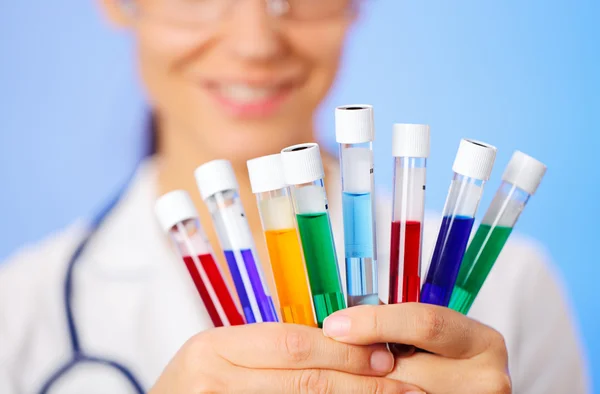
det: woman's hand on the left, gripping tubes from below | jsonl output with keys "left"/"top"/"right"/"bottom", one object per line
{"left": 150, "top": 323, "right": 419, "bottom": 394}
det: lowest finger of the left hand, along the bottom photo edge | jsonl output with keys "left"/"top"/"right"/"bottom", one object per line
{"left": 236, "top": 369, "right": 425, "bottom": 394}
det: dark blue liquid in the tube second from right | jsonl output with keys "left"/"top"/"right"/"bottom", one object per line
{"left": 421, "top": 216, "right": 474, "bottom": 306}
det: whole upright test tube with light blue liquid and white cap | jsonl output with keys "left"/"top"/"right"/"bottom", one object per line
{"left": 335, "top": 105, "right": 379, "bottom": 306}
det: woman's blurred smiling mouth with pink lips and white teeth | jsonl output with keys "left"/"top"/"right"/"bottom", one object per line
{"left": 204, "top": 81, "right": 296, "bottom": 118}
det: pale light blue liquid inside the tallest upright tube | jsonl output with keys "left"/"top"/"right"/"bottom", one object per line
{"left": 342, "top": 192, "right": 379, "bottom": 306}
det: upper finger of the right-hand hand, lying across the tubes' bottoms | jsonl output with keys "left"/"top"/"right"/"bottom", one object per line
{"left": 323, "top": 303, "right": 495, "bottom": 358}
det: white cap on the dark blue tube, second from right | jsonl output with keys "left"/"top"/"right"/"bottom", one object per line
{"left": 452, "top": 139, "right": 496, "bottom": 181}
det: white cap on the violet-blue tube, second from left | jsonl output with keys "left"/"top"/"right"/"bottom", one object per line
{"left": 194, "top": 160, "right": 238, "bottom": 200}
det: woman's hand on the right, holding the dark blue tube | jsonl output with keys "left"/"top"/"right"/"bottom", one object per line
{"left": 323, "top": 303, "right": 512, "bottom": 394}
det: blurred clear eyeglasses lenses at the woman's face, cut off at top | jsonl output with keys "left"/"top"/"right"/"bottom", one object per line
{"left": 127, "top": 0, "right": 358, "bottom": 26}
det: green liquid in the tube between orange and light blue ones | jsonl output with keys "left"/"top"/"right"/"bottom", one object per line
{"left": 296, "top": 212, "right": 346, "bottom": 327}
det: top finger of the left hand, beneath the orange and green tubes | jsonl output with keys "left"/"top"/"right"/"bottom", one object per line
{"left": 209, "top": 323, "right": 394, "bottom": 376}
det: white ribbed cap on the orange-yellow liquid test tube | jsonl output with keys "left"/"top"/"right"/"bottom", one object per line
{"left": 246, "top": 153, "right": 287, "bottom": 193}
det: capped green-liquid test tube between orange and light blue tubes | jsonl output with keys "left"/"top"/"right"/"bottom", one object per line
{"left": 281, "top": 143, "right": 346, "bottom": 327}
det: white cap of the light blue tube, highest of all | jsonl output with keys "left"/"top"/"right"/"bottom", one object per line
{"left": 335, "top": 105, "right": 375, "bottom": 144}
